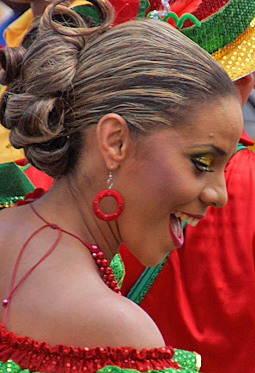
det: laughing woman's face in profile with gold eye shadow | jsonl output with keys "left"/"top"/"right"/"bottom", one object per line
{"left": 114, "top": 97, "right": 243, "bottom": 266}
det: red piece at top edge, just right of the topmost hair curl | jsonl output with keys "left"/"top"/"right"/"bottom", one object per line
{"left": 110, "top": 0, "right": 140, "bottom": 26}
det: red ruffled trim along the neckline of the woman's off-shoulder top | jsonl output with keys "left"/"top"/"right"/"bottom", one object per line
{"left": 0, "top": 324, "right": 180, "bottom": 373}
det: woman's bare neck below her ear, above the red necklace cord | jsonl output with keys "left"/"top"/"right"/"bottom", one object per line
{"left": 34, "top": 181, "right": 121, "bottom": 261}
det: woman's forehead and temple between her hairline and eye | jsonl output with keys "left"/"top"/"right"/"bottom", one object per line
{"left": 138, "top": 97, "right": 243, "bottom": 158}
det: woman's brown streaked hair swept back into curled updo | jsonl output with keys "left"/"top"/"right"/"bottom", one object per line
{"left": 0, "top": 0, "right": 235, "bottom": 178}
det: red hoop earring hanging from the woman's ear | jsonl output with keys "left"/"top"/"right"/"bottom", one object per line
{"left": 92, "top": 171, "right": 124, "bottom": 221}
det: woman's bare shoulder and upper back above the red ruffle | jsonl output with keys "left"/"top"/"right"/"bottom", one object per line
{"left": 0, "top": 206, "right": 164, "bottom": 350}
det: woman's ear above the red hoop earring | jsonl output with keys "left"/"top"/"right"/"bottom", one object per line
{"left": 96, "top": 113, "right": 130, "bottom": 169}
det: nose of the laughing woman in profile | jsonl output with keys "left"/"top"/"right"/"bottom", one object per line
{"left": 200, "top": 174, "right": 228, "bottom": 207}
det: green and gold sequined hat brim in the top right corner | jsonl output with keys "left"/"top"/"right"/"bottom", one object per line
{"left": 177, "top": 0, "right": 255, "bottom": 80}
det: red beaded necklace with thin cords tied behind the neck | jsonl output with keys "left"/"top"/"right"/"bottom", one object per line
{"left": 2, "top": 199, "right": 121, "bottom": 324}
